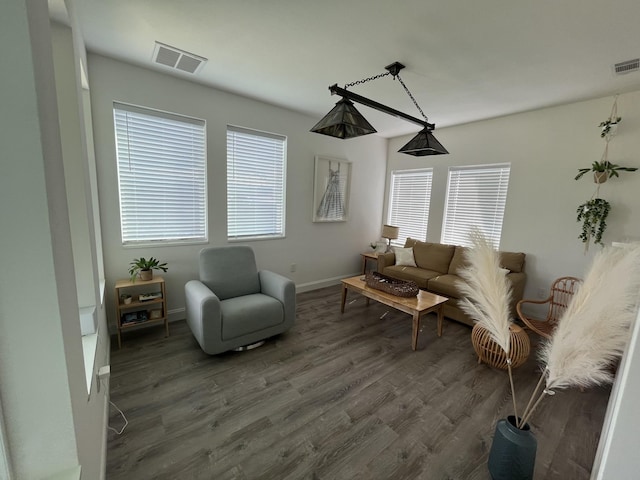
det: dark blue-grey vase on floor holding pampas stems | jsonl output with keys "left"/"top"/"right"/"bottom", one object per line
{"left": 489, "top": 415, "right": 538, "bottom": 480}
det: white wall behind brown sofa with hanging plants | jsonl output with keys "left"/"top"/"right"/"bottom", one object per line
{"left": 387, "top": 92, "right": 640, "bottom": 298}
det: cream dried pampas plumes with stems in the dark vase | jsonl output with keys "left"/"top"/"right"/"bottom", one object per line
{"left": 459, "top": 230, "right": 640, "bottom": 428}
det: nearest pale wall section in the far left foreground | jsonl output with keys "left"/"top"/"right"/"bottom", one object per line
{"left": 0, "top": 0, "right": 82, "bottom": 479}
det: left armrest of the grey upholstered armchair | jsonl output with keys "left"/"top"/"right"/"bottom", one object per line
{"left": 184, "top": 280, "right": 222, "bottom": 351}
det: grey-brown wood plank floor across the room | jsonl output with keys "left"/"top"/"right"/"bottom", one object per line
{"left": 107, "top": 286, "right": 609, "bottom": 480}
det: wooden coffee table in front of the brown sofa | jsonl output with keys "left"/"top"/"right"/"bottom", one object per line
{"left": 340, "top": 275, "right": 449, "bottom": 350}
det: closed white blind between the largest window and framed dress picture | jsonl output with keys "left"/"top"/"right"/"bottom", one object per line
{"left": 227, "top": 125, "right": 287, "bottom": 240}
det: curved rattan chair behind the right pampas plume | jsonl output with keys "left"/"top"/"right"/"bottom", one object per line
{"left": 516, "top": 277, "right": 582, "bottom": 338}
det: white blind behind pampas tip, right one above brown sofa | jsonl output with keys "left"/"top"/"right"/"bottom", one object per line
{"left": 441, "top": 164, "right": 511, "bottom": 248}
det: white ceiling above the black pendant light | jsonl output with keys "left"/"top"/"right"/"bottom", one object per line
{"left": 49, "top": 0, "right": 640, "bottom": 137}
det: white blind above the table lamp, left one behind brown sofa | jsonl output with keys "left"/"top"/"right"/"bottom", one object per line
{"left": 387, "top": 168, "right": 433, "bottom": 246}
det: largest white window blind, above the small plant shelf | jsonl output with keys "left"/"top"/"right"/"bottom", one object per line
{"left": 113, "top": 103, "right": 207, "bottom": 244}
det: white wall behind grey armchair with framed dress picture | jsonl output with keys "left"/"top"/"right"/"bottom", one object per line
{"left": 89, "top": 54, "right": 387, "bottom": 326}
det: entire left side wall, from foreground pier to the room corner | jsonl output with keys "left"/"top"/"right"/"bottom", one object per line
{"left": 0, "top": 0, "right": 109, "bottom": 480}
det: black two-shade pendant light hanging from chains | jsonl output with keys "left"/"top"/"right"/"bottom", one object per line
{"left": 311, "top": 62, "right": 449, "bottom": 157}
